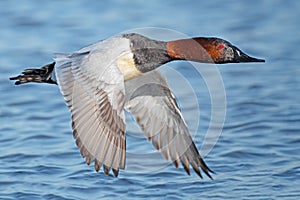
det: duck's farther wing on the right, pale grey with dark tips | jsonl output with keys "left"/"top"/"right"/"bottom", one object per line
{"left": 125, "top": 71, "right": 212, "bottom": 178}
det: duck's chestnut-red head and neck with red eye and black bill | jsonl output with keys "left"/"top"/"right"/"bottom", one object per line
{"left": 167, "top": 37, "right": 265, "bottom": 64}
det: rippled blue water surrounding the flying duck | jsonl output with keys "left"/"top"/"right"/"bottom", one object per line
{"left": 0, "top": 0, "right": 300, "bottom": 199}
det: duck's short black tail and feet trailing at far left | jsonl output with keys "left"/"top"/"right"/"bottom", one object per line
{"left": 9, "top": 62, "right": 57, "bottom": 85}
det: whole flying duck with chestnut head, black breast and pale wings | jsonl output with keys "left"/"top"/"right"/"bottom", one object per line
{"left": 10, "top": 33, "right": 264, "bottom": 178}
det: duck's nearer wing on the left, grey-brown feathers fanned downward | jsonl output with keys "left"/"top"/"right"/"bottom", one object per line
{"left": 56, "top": 51, "right": 126, "bottom": 176}
